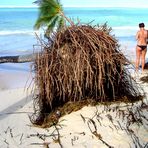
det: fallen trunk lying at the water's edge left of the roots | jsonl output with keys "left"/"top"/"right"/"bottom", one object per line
{"left": 0, "top": 53, "right": 36, "bottom": 64}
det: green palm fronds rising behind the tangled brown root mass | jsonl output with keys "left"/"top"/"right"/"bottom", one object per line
{"left": 34, "top": 0, "right": 73, "bottom": 37}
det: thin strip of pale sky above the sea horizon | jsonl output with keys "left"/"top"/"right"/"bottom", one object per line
{"left": 0, "top": 0, "right": 148, "bottom": 8}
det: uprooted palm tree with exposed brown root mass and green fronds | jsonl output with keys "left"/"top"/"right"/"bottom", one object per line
{"left": 30, "top": 0, "right": 144, "bottom": 124}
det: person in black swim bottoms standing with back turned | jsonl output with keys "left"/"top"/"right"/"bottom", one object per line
{"left": 136, "top": 23, "right": 147, "bottom": 72}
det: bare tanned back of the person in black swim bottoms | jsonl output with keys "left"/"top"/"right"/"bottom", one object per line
{"left": 136, "top": 29, "right": 147, "bottom": 46}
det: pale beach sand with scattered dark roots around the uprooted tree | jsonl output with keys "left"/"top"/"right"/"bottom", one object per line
{"left": 0, "top": 64, "right": 148, "bottom": 148}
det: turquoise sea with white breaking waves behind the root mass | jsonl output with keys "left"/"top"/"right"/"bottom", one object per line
{"left": 0, "top": 7, "right": 148, "bottom": 59}
